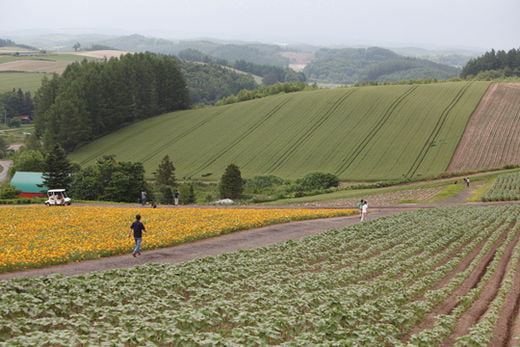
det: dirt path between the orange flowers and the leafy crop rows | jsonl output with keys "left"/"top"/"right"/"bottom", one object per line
{"left": 0, "top": 206, "right": 408, "bottom": 280}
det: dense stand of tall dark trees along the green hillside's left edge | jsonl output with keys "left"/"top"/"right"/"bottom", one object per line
{"left": 35, "top": 53, "right": 190, "bottom": 152}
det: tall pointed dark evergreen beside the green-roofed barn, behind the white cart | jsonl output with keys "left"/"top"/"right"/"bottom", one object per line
{"left": 42, "top": 144, "right": 73, "bottom": 189}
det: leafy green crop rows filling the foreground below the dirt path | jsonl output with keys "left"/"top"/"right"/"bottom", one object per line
{"left": 0, "top": 205, "right": 520, "bottom": 346}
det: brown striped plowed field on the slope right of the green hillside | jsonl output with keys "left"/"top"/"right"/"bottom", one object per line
{"left": 448, "top": 83, "right": 520, "bottom": 172}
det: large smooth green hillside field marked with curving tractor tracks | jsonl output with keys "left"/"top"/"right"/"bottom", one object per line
{"left": 70, "top": 82, "right": 489, "bottom": 180}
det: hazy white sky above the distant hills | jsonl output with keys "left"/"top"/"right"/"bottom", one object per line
{"left": 0, "top": 0, "right": 520, "bottom": 50}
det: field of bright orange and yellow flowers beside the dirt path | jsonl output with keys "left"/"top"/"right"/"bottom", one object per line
{"left": 0, "top": 206, "right": 356, "bottom": 272}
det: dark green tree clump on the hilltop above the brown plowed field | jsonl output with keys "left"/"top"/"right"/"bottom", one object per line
{"left": 460, "top": 48, "right": 520, "bottom": 78}
